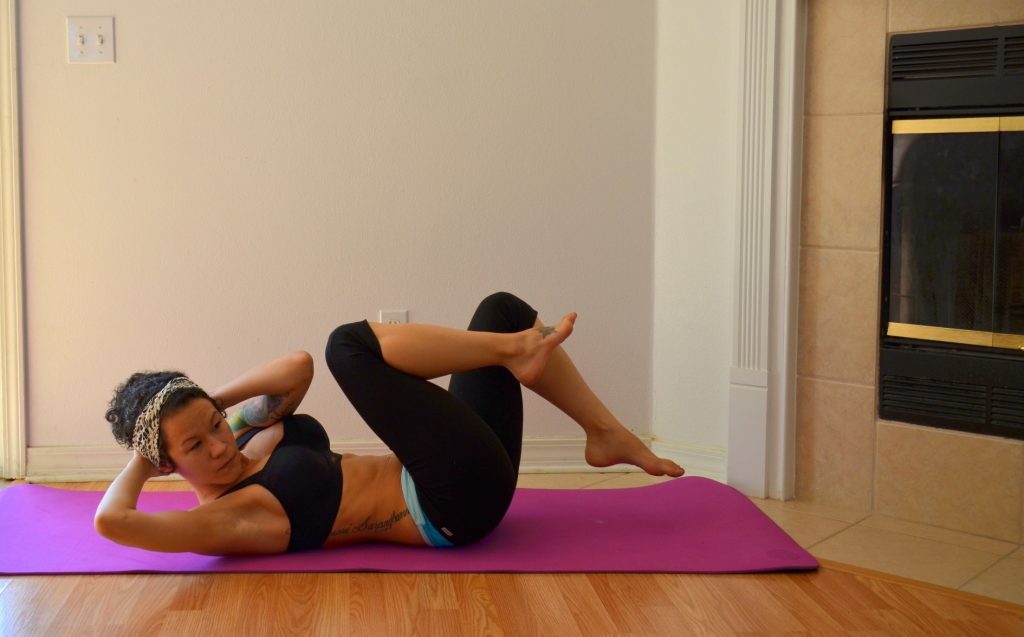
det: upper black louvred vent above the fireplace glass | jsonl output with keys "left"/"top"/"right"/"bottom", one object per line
{"left": 889, "top": 25, "right": 1024, "bottom": 115}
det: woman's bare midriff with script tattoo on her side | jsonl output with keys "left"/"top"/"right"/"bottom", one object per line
{"left": 324, "top": 454, "right": 424, "bottom": 547}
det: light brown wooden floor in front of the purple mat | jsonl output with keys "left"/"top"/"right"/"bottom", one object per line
{"left": 0, "top": 563, "right": 1024, "bottom": 637}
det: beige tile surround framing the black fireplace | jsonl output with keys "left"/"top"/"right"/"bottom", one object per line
{"left": 786, "top": 0, "right": 1024, "bottom": 553}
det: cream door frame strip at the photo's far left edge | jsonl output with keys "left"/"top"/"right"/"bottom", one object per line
{"left": 0, "top": 0, "right": 28, "bottom": 478}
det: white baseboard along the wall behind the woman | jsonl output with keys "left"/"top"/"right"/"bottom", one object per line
{"left": 26, "top": 436, "right": 725, "bottom": 482}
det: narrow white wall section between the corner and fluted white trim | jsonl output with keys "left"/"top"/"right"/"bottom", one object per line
{"left": 652, "top": 0, "right": 740, "bottom": 454}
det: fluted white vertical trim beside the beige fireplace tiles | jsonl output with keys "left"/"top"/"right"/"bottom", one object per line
{"left": 727, "top": 0, "right": 807, "bottom": 500}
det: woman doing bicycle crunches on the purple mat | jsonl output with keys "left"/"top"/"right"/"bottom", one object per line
{"left": 95, "top": 293, "right": 683, "bottom": 555}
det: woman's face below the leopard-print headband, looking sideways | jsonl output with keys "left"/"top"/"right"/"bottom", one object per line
{"left": 160, "top": 397, "right": 244, "bottom": 484}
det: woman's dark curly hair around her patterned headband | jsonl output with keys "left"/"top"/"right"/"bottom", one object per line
{"left": 106, "top": 371, "right": 223, "bottom": 466}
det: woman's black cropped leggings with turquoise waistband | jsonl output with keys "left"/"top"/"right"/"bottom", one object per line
{"left": 327, "top": 292, "right": 537, "bottom": 546}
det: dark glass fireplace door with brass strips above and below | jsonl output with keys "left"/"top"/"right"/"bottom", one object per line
{"left": 887, "top": 117, "right": 1024, "bottom": 349}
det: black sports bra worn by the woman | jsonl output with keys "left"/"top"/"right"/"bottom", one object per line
{"left": 218, "top": 414, "right": 341, "bottom": 552}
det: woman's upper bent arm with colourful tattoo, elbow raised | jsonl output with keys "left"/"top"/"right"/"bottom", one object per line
{"left": 210, "top": 351, "right": 313, "bottom": 429}
